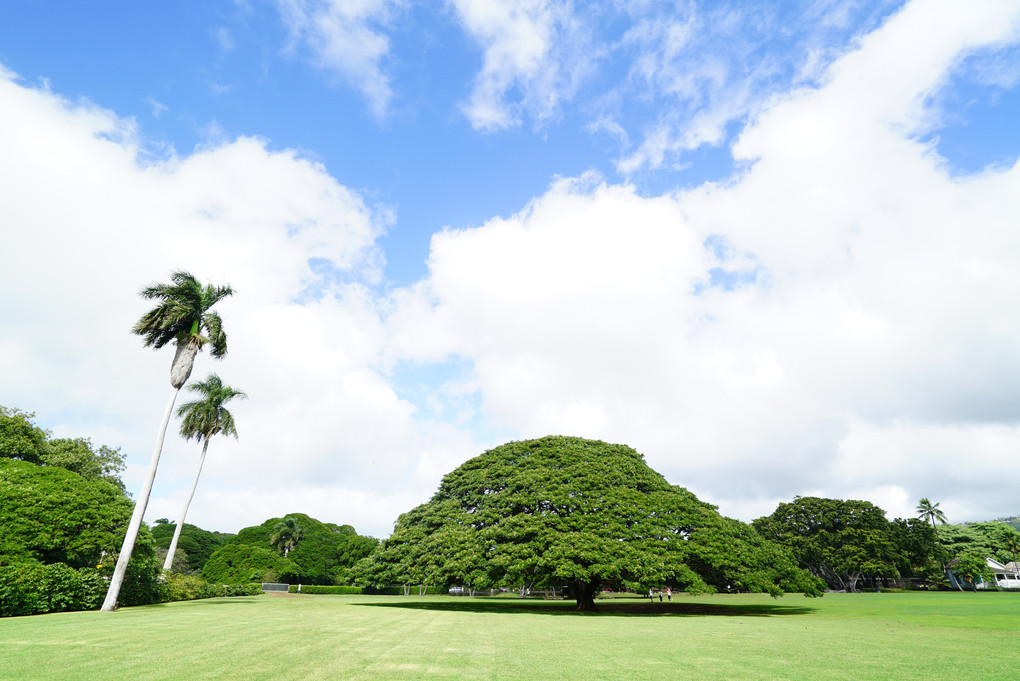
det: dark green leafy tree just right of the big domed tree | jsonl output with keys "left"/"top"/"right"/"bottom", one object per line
{"left": 753, "top": 496, "right": 898, "bottom": 591}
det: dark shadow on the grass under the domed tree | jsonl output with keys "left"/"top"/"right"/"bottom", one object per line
{"left": 352, "top": 596, "right": 814, "bottom": 617}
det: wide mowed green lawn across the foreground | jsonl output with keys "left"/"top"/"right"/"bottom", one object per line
{"left": 0, "top": 592, "right": 1020, "bottom": 681}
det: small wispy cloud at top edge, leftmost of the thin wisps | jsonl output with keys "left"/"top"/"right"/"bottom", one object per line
{"left": 277, "top": 0, "right": 404, "bottom": 116}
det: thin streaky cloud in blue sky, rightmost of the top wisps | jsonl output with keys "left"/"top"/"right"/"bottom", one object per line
{"left": 603, "top": 1, "right": 901, "bottom": 176}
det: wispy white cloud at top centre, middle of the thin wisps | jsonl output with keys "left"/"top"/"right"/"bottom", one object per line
{"left": 448, "top": 0, "right": 602, "bottom": 132}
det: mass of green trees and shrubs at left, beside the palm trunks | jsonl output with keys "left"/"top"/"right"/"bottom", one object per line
{"left": 0, "top": 406, "right": 259, "bottom": 616}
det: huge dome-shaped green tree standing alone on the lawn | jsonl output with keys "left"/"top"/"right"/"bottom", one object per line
{"left": 366, "top": 436, "right": 820, "bottom": 610}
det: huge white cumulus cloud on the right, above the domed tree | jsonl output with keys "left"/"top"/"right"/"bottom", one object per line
{"left": 390, "top": 3, "right": 1020, "bottom": 519}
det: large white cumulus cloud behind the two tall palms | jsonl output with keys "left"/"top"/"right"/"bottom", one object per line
{"left": 0, "top": 67, "right": 472, "bottom": 534}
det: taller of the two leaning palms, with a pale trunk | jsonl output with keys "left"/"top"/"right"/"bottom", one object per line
{"left": 101, "top": 271, "right": 234, "bottom": 613}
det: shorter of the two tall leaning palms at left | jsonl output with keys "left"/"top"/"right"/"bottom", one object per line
{"left": 163, "top": 373, "right": 248, "bottom": 570}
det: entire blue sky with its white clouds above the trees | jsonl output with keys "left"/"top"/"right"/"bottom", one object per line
{"left": 0, "top": 0, "right": 1020, "bottom": 535}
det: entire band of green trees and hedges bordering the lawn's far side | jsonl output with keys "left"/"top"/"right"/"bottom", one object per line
{"left": 0, "top": 407, "right": 1020, "bottom": 615}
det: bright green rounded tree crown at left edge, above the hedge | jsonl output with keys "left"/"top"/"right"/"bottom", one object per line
{"left": 0, "top": 459, "right": 132, "bottom": 568}
